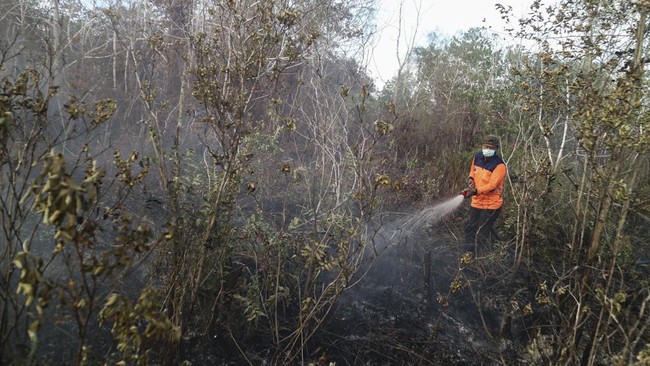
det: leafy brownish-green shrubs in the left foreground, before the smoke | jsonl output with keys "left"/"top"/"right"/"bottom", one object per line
{"left": 0, "top": 60, "right": 178, "bottom": 364}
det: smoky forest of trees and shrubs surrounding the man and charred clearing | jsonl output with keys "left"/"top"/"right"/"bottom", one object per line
{"left": 0, "top": 0, "right": 650, "bottom": 365}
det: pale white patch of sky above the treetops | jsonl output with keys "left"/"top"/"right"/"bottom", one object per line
{"left": 368, "top": 0, "right": 532, "bottom": 88}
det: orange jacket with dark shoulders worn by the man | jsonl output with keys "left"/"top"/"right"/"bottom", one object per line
{"left": 469, "top": 152, "right": 507, "bottom": 210}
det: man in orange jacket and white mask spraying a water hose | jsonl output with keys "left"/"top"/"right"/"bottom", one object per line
{"left": 461, "top": 135, "right": 507, "bottom": 251}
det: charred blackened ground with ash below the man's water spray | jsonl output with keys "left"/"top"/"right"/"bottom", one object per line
{"left": 321, "top": 214, "right": 534, "bottom": 365}
